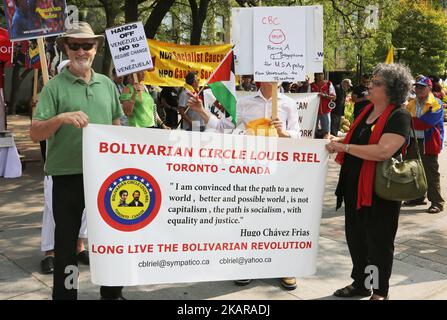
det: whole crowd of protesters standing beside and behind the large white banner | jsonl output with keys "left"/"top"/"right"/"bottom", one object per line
{"left": 27, "top": 23, "right": 446, "bottom": 300}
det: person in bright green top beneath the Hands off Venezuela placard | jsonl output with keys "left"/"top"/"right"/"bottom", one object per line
{"left": 120, "top": 71, "right": 170, "bottom": 129}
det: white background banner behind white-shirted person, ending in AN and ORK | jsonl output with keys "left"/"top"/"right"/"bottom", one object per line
{"left": 236, "top": 91, "right": 320, "bottom": 139}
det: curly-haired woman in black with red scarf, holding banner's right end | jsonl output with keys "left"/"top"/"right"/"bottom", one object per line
{"left": 326, "top": 64, "right": 412, "bottom": 300}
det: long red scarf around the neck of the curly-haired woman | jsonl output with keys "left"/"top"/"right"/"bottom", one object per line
{"left": 335, "top": 103, "right": 395, "bottom": 210}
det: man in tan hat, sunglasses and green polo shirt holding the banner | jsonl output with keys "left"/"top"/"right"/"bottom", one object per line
{"left": 30, "top": 22, "right": 122, "bottom": 300}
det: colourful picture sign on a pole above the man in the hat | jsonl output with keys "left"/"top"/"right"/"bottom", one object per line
{"left": 4, "top": 0, "right": 67, "bottom": 41}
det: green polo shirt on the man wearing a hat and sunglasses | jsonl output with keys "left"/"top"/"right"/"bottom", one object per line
{"left": 33, "top": 68, "right": 123, "bottom": 176}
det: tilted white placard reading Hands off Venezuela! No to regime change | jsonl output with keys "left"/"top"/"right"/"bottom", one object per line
{"left": 106, "top": 21, "right": 153, "bottom": 76}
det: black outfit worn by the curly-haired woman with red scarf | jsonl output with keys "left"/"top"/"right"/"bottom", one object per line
{"left": 336, "top": 109, "right": 411, "bottom": 296}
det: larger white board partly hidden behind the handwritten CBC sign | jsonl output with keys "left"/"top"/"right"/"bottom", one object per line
{"left": 231, "top": 6, "right": 324, "bottom": 75}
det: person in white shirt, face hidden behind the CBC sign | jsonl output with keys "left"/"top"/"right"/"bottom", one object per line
{"left": 188, "top": 82, "right": 300, "bottom": 290}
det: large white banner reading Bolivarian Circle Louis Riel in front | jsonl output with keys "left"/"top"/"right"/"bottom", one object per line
{"left": 83, "top": 125, "right": 328, "bottom": 286}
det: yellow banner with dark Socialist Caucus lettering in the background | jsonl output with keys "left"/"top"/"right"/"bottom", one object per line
{"left": 144, "top": 40, "right": 232, "bottom": 87}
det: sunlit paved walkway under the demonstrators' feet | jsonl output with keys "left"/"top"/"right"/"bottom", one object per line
{"left": 0, "top": 116, "right": 447, "bottom": 300}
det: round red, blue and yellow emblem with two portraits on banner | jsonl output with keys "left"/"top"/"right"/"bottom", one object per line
{"left": 98, "top": 169, "right": 161, "bottom": 231}
